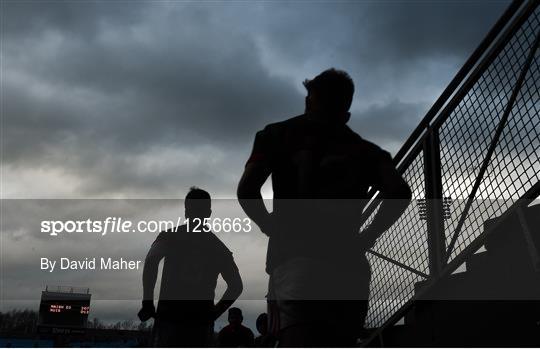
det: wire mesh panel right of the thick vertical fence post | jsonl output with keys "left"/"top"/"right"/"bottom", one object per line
{"left": 440, "top": 4, "right": 540, "bottom": 259}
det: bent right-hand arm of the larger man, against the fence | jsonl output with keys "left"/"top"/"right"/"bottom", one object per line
{"left": 360, "top": 157, "right": 412, "bottom": 249}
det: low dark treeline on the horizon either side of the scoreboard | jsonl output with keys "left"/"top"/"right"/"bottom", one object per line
{"left": 0, "top": 309, "right": 152, "bottom": 333}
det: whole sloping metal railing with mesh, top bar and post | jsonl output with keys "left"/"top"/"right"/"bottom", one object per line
{"left": 363, "top": 0, "right": 540, "bottom": 335}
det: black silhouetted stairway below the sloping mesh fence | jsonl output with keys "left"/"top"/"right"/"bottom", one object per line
{"left": 378, "top": 205, "right": 540, "bottom": 347}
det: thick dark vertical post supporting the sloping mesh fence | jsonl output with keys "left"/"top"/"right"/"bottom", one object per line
{"left": 423, "top": 128, "right": 446, "bottom": 277}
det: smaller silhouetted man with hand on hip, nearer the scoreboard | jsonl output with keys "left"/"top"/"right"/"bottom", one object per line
{"left": 139, "top": 187, "right": 242, "bottom": 347}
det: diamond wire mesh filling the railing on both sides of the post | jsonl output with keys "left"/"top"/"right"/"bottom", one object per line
{"left": 364, "top": 1, "right": 540, "bottom": 327}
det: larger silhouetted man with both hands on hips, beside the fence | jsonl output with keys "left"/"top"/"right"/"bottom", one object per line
{"left": 238, "top": 69, "right": 411, "bottom": 347}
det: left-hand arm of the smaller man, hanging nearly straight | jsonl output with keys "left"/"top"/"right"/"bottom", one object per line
{"left": 138, "top": 237, "right": 165, "bottom": 321}
